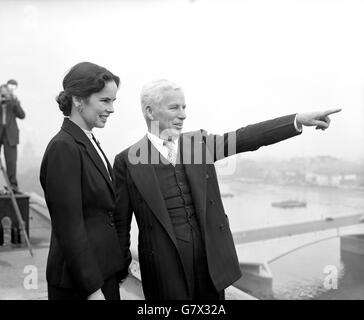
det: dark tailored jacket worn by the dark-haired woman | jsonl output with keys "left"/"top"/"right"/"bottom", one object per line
{"left": 40, "top": 118, "right": 130, "bottom": 295}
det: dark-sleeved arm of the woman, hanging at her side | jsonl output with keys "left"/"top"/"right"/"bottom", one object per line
{"left": 41, "top": 141, "right": 104, "bottom": 296}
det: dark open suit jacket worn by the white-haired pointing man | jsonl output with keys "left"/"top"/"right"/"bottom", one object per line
{"left": 114, "top": 115, "right": 299, "bottom": 299}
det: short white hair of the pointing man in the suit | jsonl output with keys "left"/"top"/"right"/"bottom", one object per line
{"left": 140, "top": 79, "right": 182, "bottom": 120}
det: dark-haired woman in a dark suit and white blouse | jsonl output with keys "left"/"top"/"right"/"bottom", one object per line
{"left": 40, "top": 62, "right": 130, "bottom": 300}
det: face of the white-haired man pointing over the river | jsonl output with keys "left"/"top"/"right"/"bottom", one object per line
{"left": 152, "top": 89, "right": 186, "bottom": 138}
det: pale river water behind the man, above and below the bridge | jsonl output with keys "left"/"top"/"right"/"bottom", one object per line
{"left": 220, "top": 181, "right": 364, "bottom": 299}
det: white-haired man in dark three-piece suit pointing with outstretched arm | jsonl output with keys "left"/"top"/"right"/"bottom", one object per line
{"left": 114, "top": 80, "right": 340, "bottom": 300}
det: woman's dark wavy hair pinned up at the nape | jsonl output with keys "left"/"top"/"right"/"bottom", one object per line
{"left": 56, "top": 62, "right": 120, "bottom": 116}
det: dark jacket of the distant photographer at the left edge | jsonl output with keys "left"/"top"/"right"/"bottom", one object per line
{"left": 0, "top": 97, "right": 25, "bottom": 146}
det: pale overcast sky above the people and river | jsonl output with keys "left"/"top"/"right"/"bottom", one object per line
{"left": 0, "top": 0, "right": 364, "bottom": 165}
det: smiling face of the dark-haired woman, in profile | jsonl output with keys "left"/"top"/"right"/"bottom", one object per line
{"left": 79, "top": 81, "right": 118, "bottom": 130}
